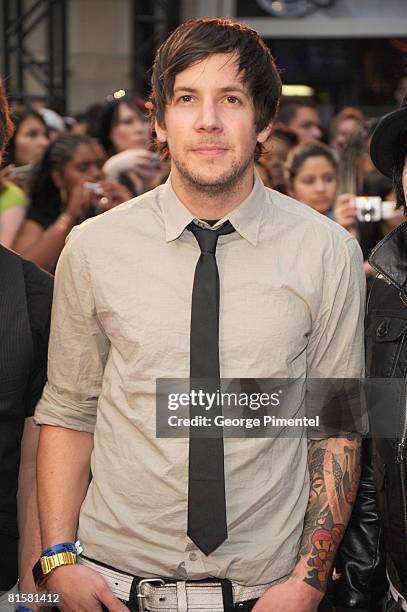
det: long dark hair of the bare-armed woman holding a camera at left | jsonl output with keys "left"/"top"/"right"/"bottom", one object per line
{"left": 30, "top": 134, "right": 92, "bottom": 217}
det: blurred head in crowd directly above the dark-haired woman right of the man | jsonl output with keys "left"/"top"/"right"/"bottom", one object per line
{"left": 277, "top": 98, "right": 322, "bottom": 144}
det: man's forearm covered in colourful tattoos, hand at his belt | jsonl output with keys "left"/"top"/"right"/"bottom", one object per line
{"left": 253, "top": 437, "right": 361, "bottom": 612}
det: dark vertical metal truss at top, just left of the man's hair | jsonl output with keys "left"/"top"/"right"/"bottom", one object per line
{"left": 131, "top": 0, "right": 180, "bottom": 97}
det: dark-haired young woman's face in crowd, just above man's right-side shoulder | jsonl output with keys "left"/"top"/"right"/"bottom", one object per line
{"left": 285, "top": 142, "right": 337, "bottom": 216}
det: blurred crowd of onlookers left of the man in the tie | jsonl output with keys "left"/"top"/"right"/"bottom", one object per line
{"left": 0, "top": 97, "right": 168, "bottom": 272}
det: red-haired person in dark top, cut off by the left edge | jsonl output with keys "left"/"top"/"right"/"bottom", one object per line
{"left": 0, "top": 82, "right": 52, "bottom": 612}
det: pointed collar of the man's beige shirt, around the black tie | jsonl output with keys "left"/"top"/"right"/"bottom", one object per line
{"left": 161, "top": 172, "right": 266, "bottom": 246}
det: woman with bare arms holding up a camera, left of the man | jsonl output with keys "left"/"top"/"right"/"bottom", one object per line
{"left": 13, "top": 134, "right": 103, "bottom": 271}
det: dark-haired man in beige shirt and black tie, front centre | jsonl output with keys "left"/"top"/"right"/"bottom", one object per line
{"left": 35, "top": 19, "right": 364, "bottom": 612}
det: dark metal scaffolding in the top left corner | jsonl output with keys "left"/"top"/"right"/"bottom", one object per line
{"left": 0, "top": 0, "right": 67, "bottom": 113}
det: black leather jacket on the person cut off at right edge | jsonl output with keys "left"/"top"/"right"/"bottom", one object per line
{"left": 331, "top": 222, "right": 407, "bottom": 610}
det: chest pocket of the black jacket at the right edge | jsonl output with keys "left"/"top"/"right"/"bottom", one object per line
{"left": 366, "top": 312, "right": 407, "bottom": 378}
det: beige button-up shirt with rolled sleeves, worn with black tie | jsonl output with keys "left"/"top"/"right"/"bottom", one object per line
{"left": 36, "top": 176, "right": 365, "bottom": 585}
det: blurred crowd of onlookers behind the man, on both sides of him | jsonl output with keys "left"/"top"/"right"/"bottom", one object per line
{"left": 0, "top": 77, "right": 403, "bottom": 274}
